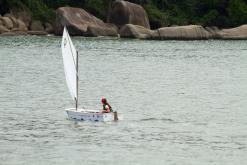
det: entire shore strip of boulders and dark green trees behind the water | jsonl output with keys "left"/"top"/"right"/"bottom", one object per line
{"left": 0, "top": 0, "right": 247, "bottom": 40}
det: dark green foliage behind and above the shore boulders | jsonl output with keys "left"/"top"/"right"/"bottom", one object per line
{"left": 2, "top": 0, "right": 247, "bottom": 28}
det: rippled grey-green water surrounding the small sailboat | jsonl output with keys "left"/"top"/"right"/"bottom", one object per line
{"left": 0, "top": 36, "right": 247, "bottom": 165}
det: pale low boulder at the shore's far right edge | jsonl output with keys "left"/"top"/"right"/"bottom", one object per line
{"left": 217, "top": 24, "right": 247, "bottom": 39}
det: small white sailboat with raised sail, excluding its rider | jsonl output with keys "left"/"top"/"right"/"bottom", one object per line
{"left": 61, "top": 27, "right": 118, "bottom": 121}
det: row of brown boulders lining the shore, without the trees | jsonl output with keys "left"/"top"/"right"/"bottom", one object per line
{"left": 0, "top": 1, "right": 247, "bottom": 40}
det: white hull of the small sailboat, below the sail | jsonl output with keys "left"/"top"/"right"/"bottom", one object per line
{"left": 66, "top": 108, "right": 118, "bottom": 122}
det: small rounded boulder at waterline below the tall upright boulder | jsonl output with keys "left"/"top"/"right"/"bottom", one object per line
{"left": 119, "top": 24, "right": 158, "bottom": 39}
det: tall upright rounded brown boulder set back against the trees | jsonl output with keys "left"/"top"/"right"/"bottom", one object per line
{"left": 108, "top": 1, "right": 150, "bottom": 29}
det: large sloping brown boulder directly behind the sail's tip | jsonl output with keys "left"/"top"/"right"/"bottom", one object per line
{"left": 54, "top": 7, "right": 113, "bottom": 35}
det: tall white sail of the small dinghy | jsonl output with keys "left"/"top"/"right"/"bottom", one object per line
{"left": 61, "top": 27, "right": 77, "bottom": 100}
